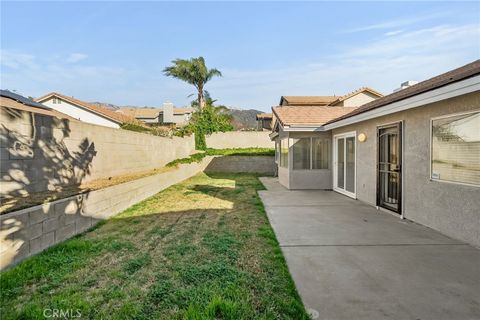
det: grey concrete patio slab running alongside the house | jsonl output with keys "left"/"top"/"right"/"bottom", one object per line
{"left": 259, "top": 178, "right": 480, "bottom": 320}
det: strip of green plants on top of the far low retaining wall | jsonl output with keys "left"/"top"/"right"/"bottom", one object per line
{"left": 166, "top": 148, "right": 275, "bottom": 167}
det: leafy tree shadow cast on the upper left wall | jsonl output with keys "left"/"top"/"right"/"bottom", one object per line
{"left": 0, "top": 107, "right": 96, "bottom": 208}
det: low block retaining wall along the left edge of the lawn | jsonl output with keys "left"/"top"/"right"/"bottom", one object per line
{"left": 0, "top": 157, "right": 212, "bottom": 269}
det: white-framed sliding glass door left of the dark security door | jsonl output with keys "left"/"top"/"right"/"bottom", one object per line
{"left": 333, "top": 132, "right": 356, "bottom": 198}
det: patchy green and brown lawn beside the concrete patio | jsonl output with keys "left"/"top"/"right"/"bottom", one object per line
{"left": 0, "top": 173, "right": 308, "bottom": 319}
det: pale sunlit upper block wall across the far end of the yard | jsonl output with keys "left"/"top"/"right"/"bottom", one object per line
{"left": 206, "top": 131, "right": 275, "bottom": 149}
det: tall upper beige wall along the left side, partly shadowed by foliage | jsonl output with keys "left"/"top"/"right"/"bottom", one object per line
{"left": 0, "top": 107, "right": 195, "bottom": 196}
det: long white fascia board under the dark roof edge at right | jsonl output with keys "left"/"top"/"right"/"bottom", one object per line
{"left": 323, "top": 75, "right": 480, "bottom": 130}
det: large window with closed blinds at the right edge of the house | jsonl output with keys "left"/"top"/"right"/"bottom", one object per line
{"left": 431, "top": 111, "right": 480, "bottom": 186}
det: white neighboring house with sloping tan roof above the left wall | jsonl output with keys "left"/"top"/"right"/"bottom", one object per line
{"left": 35, "top": 92, "right": 135, "bottom": 128}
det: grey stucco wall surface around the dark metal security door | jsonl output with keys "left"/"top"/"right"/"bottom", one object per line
{"left": 333, "top": 92, "right": 480, "bottom": 247}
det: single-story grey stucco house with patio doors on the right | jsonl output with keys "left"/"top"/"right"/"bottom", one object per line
{"left": 270, "top": 60, "right": 480, "bottom": 246}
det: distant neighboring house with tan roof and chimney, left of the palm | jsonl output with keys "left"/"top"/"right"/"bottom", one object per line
{"left": 116, "top": 102, "right": 195, "bottom": 126}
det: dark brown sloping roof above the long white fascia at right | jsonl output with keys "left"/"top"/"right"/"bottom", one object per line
{"left": 329, "top": 60, "right": 480, "bottom": 123}
